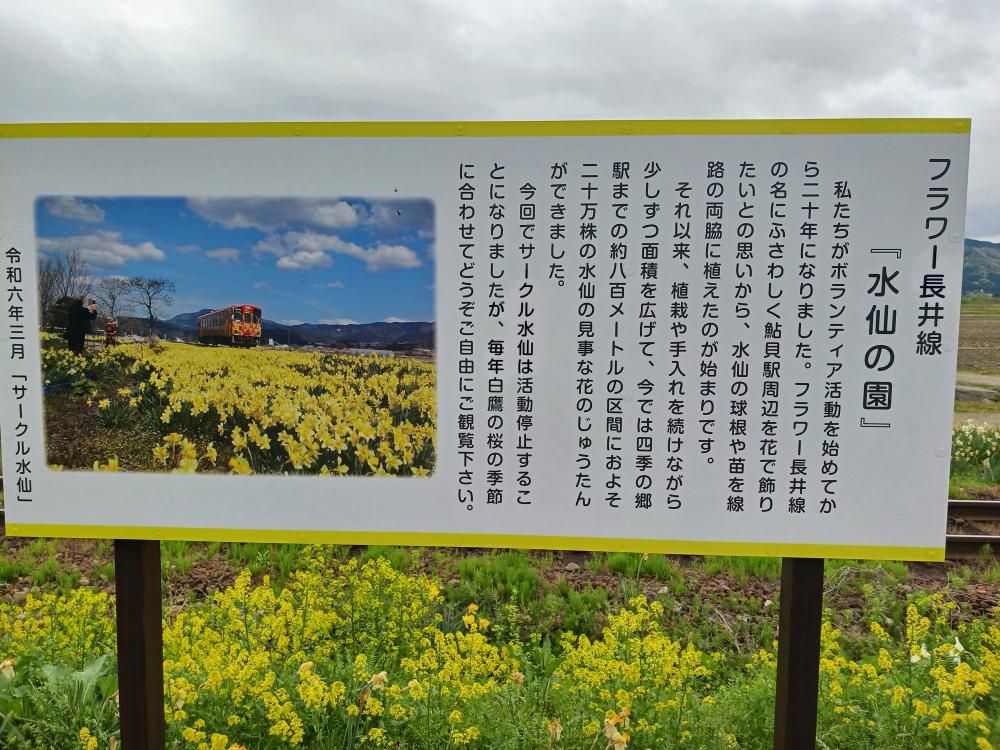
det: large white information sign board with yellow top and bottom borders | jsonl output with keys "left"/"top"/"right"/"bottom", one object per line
{"left": 0, "top": 119, "right": 970, "bottom": 559}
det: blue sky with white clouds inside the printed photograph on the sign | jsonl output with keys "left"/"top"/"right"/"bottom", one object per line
{"left": 35, "top": 196, "right": 435, "bottom": 324}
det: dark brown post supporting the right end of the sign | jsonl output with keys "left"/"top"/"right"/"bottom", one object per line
{"left": 774, "top": 557, "right": 823, "bottom": 750}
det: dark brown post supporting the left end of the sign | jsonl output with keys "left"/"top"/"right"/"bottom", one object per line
{"left": 115, "top": 539, "right": 165, "bottom": 750}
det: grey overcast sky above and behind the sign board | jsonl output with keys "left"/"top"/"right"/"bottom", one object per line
{"left": 0, "top": 0, "right": 1000, "bottom": 241}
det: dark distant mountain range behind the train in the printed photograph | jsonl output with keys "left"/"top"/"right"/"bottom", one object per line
{"left": 118, "top": 307, "right": 434, "bottom": 349}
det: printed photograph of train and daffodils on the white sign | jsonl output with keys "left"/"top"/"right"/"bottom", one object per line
{"left": 35, "top": 196, "right": 437, "bottom": 477}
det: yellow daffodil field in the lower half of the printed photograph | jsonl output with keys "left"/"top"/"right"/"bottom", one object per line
{"left": 42, "top": 339, "right": 436, "bottom": 477}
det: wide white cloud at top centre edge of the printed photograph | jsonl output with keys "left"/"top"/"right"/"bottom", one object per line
{"left": 188, "top": 198, "right": 365, "bottom": 232}
